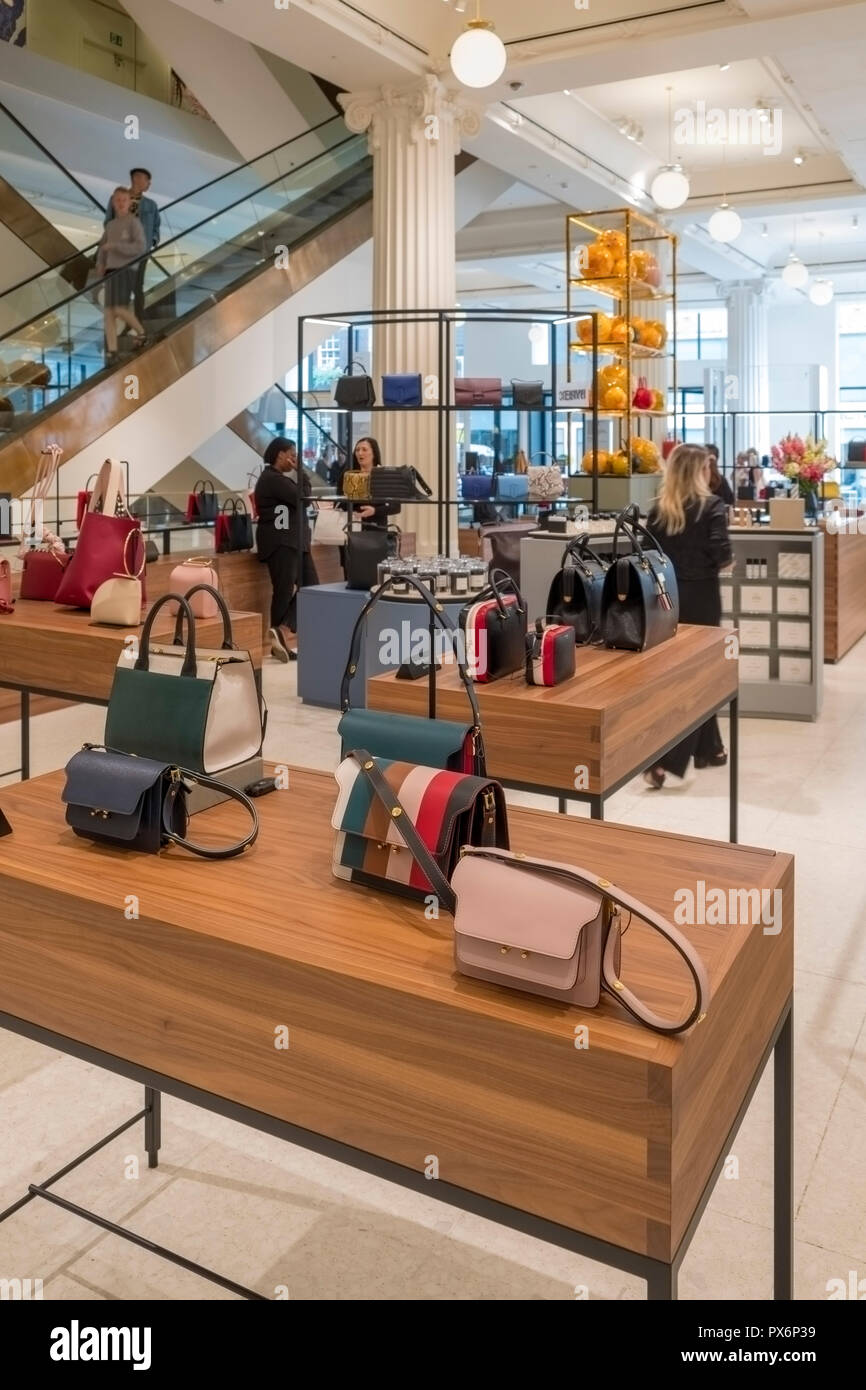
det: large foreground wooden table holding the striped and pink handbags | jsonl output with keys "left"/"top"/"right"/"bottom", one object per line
{"left": 0, "top": 770, "right": 794, "bottom": 1298}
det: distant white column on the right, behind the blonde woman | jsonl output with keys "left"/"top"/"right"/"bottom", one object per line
{"left": 724, "top": 282, "right": 773, "bottom": 455}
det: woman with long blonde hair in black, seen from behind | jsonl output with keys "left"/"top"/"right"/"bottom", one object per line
{"left": 644, "top": 443, "right": 731, "bottom": 791}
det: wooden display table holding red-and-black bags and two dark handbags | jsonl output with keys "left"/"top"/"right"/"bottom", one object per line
{"left": 367, "top": 626, "right": 738, "bottom": 841}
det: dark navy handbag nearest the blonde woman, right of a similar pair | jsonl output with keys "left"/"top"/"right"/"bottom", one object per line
{"left": 601, "top": 503, "right": 680, "bottom": 652}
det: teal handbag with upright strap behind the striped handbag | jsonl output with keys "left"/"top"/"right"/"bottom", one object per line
{"left": 338, "top": 574, "right": 487, "bottom": 777}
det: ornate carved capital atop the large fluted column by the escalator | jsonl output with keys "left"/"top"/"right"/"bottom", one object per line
{"left": 338, "top": 72, "right": 481, "bottom": 154}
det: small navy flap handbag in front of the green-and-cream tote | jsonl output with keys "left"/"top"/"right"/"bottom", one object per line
{"left": 61, "top": 744, "right": 259, "bottom": 859}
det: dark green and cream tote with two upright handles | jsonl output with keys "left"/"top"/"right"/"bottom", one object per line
{"left": 106, "top": 589, "right": 264, "bottom": 774}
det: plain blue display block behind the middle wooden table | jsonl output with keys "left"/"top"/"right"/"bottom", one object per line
{"left": 297, "top": 584, "right": 466, "bottom": 709}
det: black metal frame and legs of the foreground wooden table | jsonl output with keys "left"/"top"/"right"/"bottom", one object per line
{"left": 0, "top": 997, "right": 794, "bottom": 1301}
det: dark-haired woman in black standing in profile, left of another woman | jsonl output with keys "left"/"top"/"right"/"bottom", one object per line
{"left": 256, "top": 436, "right": 318, "bottom": 662}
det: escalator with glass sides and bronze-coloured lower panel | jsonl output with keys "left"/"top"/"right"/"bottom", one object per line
{"left": 0, "top": 117, "right": 373, "bottom": 493}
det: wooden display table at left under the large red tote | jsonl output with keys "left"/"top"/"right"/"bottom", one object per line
{"left": 0, "top": 599, "right": 261, "bottom": 778}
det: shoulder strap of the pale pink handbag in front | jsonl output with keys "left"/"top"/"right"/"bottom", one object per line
{"left": 464, "top": 847, "right": 709, "bottom": 1034}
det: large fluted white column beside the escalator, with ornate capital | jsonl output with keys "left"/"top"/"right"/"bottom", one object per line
{"left": 339, "top": 74, "right": 481, "bottom": 555}
